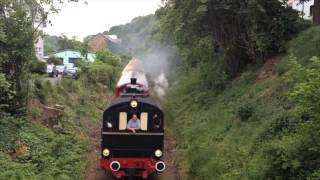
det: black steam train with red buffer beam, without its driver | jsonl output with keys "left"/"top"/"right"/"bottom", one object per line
{"left": 100, "top": 59, "right": 166, "bottom": 179}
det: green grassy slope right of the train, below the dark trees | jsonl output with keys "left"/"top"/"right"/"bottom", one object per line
{"left": 166, "top": 27, "right": 320, "bottom": 179}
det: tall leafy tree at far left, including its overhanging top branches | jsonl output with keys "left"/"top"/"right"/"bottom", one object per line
{"left": 0, "top": 0, "right": 77, "bottom": 114}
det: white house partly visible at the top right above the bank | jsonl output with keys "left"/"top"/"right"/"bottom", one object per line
{"left": 288, "top": 0, "right": 314, "bottom": 19}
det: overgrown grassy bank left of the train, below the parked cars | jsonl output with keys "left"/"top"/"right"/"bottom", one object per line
{"left": 0, "top": 79, "right": 110, "bottom": 179}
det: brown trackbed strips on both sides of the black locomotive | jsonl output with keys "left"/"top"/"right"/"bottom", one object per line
{"left": 84, "top": 121, "right": 180, "bottom": 180}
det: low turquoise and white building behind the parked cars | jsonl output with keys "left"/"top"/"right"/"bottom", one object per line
{"left": 49, "top": 49, "right": 96, "bottom": 65}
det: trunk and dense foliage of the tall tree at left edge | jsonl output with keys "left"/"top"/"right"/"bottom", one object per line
{"left": 0, "top": 0, "right": 35, "bottom": 112}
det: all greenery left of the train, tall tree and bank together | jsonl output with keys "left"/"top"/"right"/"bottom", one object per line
{"left": 0, "top": 0, "right": 105, "bottom": 179}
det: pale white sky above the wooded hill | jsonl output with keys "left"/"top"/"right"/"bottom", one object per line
{"left": 44, "top": 0, "right": 161, "bottom": 40}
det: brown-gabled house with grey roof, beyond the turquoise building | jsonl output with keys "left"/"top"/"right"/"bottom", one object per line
{"left": 88, "top": 33, "right": 121, "bottom": 52}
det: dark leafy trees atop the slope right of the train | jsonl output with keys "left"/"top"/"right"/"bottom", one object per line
{"left": 156, "top": 0, "right": 301, "bottom": 76}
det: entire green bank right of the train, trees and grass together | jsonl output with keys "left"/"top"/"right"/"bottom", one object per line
{"left": 156, "top": 0, "right": 320, "bottom": 180}
